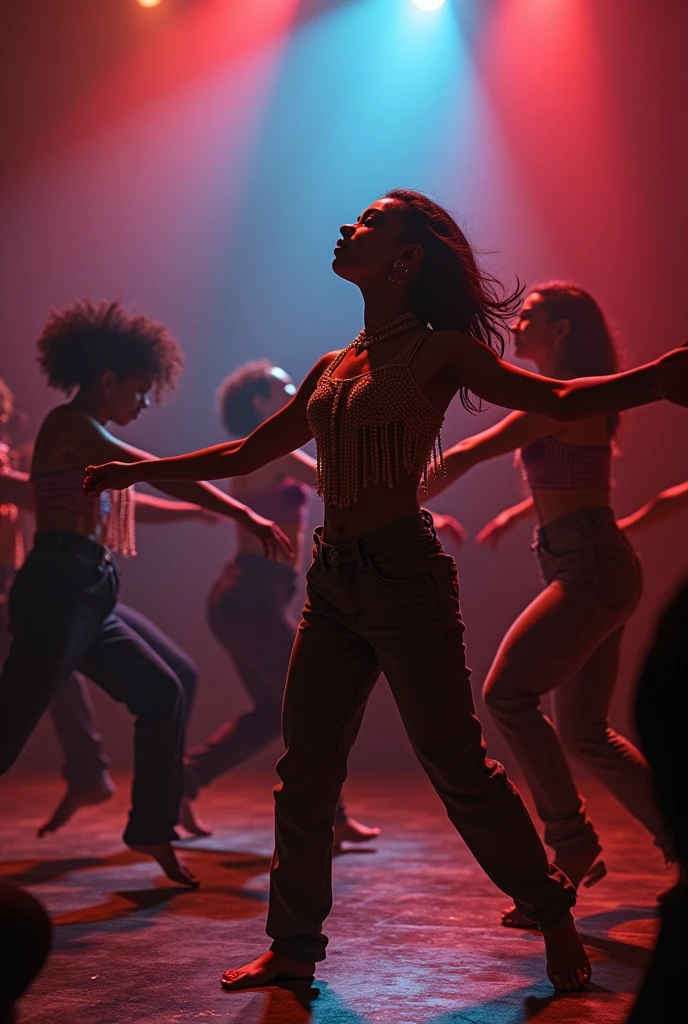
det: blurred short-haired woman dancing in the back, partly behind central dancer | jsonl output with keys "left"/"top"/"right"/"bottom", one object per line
{"left": 179, "top": 359, "right": 380, "bottom": 848}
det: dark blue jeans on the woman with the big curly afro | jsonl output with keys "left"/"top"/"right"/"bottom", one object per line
{"left": 0, "top": 530, "right": 184, "bottom": 846}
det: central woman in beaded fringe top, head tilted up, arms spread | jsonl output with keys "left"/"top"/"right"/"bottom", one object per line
{"left": 86, "top": 189, "right": 688, "bottom": 990}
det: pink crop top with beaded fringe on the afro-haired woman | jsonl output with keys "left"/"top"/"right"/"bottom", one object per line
{"left": 31, "top": 466, "right": 136, "bottom": 556}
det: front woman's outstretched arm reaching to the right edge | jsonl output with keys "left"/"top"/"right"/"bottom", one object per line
{"left": 437, "top": 331, "right": 688, "bottom": 422}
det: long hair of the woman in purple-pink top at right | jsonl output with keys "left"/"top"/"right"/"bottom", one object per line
{"left": 530, "top": 281, "right": 620, "bottom": 439}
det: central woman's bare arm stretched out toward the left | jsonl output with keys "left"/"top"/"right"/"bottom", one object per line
{"left": 86, "top": 352, "right": 335, "bottom": 493}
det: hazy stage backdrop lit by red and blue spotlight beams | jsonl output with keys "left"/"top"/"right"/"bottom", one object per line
{"left": 0, "top": 0, "right": 688, "bottom": 772}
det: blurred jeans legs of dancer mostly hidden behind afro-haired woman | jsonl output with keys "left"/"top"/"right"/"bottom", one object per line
{"left": 48, "top": 602, "right": 198, "bottom": 790}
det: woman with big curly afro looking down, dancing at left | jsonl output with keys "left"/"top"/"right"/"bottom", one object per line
{"left": 0, "top": 302, "right": 291, "bottom": 885}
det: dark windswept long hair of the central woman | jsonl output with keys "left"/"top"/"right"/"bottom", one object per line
{"left": 385, "top": 188, "right": 523, "bottom": 412}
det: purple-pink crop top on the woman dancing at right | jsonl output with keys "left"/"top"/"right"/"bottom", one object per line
{"left": 519, "top": 435, "right": 611, "bottom": 490}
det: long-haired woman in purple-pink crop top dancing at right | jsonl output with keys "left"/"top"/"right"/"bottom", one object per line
{"left": 433, "top": 282, "right": 672, "bottom": 928}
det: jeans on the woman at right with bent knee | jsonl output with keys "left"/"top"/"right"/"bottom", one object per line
{"left": 483, "top": 508, "right": 669, "bottom": 860}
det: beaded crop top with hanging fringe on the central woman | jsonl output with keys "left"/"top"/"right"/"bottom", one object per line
{"left": 307, "top": 328, "right": 444, "bottom": 508}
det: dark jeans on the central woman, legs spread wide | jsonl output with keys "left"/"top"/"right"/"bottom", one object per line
{"left": 267, "top": 511, "right": 575, "bottom": 963}
